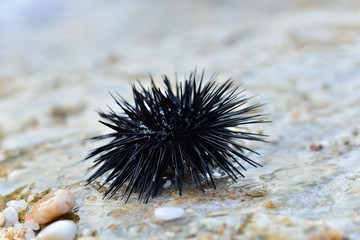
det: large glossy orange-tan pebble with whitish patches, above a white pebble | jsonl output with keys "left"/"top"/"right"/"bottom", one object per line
{"left": 32, "top": 189, "right": 75, "bottom": 224}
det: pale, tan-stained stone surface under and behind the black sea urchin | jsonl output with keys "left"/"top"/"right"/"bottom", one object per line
{"left": 0, "top": 0, "right": 360, "bottom": 239}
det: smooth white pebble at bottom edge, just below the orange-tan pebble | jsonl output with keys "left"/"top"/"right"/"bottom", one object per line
{"left": 36, "top": 220, "right": 76, "bottom": 240}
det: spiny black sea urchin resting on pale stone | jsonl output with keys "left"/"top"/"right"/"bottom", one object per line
{"left": 86, "top": 72, "right": 266, "bottom": 203}
